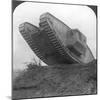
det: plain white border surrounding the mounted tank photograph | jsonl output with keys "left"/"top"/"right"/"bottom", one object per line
{"left": 0, "top": 0, "right": 100, "bottom": 100}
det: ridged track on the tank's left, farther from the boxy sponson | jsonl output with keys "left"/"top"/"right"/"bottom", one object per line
{"left": 19, "top": 22, "right": 47, "bottom": 63}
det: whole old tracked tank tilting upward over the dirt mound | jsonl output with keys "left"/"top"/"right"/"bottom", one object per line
{"left": 19, "top": 13, "right": 94, "bottom": 65}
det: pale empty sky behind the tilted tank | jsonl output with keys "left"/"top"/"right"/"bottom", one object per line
{"left": 13, "top": 2, "right": 96, "bottom": 69}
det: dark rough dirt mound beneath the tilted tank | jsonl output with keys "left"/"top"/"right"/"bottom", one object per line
{"left": 12, "top": 60, "right": 97, "bottom": 99}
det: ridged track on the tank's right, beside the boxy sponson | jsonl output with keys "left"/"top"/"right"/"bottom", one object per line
{"left": 39, "top": 18, "right": 80, "bottom": 63}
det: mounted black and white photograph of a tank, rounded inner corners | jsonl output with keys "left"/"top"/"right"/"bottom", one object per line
{"left": 12, "top": 0, "right": 98, "bottom": 100}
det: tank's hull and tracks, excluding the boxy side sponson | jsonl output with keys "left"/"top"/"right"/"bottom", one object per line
{"left": 19, "top": 13, "right": 94, "bottom": 65}
